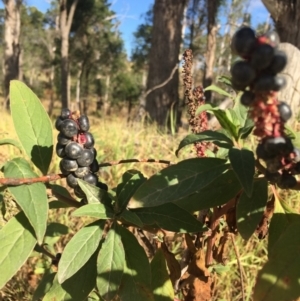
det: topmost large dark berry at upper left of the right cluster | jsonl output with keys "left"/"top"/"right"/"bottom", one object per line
{"left": 231, "top": 27, "right": 256, "bottom": 57}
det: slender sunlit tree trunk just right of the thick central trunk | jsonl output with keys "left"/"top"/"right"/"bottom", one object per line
{"left": 203, "top": 0, "right": 219, "bottom": 102}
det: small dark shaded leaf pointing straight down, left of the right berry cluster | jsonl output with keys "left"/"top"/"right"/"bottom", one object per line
{"left": 228, "top": 148, "right": 255, "bottom": 197}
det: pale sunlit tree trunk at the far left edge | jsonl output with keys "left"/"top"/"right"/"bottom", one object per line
{"left": 4, "top": 0, "right": 22, "bottom": 109}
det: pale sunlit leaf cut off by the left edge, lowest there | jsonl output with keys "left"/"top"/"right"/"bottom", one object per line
{"left": 0, "top": 212, "right": 36, "bottom": 289}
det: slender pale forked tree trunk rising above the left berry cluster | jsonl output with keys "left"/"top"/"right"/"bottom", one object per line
{"left": 59, "top": 0, "right": 79, "bottom": 108}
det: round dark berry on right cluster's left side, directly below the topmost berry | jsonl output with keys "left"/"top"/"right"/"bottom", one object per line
{"left": 230, "top": 61, "right": 256, "bottom": 87}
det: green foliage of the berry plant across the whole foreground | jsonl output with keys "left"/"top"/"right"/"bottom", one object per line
{"left": 0, "top": 81, "right": 300, "bottom": 301}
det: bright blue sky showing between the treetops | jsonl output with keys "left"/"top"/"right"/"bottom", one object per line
{"left": 0, "top": 0, "right": 268, "bottom": 56}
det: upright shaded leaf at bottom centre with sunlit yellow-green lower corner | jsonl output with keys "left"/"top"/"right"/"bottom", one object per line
{"left": 151, "top": 249, "right": 174, "bottom": 301}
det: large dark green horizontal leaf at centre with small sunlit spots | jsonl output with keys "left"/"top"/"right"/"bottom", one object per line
{"left": 128, "top": 158, "right": 228, "bottom": 208}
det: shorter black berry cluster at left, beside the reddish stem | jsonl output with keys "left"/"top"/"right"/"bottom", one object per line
{"left": 55, "top": 109, "right": 107, "bottom": 198}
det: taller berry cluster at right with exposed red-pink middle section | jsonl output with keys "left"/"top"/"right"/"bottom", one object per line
{"left": 231, "top": 27, "right": 300, "bottom": 188}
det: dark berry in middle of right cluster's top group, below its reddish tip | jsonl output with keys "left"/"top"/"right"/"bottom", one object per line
{"left": 251, "top": 44, "right": 274, "bottom": 70}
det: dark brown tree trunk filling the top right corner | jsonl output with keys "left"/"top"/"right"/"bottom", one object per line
{"left": 262, "top": 0, "right": 300, "bottom": 49}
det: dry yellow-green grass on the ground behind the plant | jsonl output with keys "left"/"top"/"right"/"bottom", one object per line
{"left": 0, "top": 108, "right": 299, "bottom": 301}
